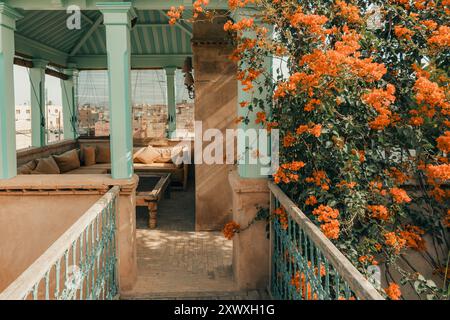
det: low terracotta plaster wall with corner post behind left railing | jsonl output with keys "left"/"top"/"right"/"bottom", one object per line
{"left": 0, "top": 174, "right": 138, "bottom": 292}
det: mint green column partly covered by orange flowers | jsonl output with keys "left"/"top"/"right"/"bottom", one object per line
{"left": 237, "top": 14, "right": 273, "bottom": 179}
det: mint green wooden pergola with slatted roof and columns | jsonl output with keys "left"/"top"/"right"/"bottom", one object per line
{"left": 0, "top": 0, "right": 270, "bottom": 179}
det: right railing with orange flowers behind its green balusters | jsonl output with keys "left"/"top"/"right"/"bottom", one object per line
{"left": 269, "top": 182, "right": 384, "bottom": 300}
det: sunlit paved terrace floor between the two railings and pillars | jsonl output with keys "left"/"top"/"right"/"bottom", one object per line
{"left": 121, "top": 180, "right": 266, "bottom": 300}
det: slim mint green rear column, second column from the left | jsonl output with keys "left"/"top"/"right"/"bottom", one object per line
{"left": 30, "top": 59, "right": 48, "bottom": 147}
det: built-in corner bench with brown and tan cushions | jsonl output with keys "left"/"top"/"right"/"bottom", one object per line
{"left": 17, "top": 139, "right": 192, "bottom": 190}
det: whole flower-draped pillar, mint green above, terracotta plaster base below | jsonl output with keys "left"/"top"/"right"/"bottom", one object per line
{"left": 229, "top": 12, "right": 272, "bottom": 290}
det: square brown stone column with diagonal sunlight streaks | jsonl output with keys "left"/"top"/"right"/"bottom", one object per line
{"left": 192, "top": 15, "right": 237, "bottom": 231}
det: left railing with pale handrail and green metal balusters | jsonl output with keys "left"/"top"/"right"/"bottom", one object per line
{"left": 0, "top": 186, "right": 120, "bottom": 300}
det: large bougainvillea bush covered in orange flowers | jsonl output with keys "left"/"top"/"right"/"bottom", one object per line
{"left": 172, "top": 0, "right": 450, "bottom": 299}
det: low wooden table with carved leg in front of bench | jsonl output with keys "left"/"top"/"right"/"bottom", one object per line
{"left": 136, "top": 173, "right": 170, "bottom": 229}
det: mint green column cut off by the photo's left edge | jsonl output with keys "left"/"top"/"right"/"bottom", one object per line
{"left": 0, "top": 2, "right": 22, "bottom": 179}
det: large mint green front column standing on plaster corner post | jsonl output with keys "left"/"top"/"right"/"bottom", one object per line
{"left": 97, "top": 2, "right": 136, "bottom": 179}
